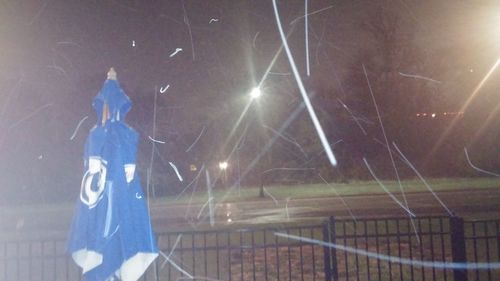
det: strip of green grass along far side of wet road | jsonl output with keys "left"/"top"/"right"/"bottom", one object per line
{"left": 156, "top": 178, "right": 500, "bottom": 204}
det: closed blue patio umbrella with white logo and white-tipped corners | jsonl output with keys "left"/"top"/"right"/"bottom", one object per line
{"left": 68, "top": 68, "right": 158, "bottom": 281}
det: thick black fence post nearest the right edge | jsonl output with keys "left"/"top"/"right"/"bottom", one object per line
{"left": 450, "top": 217, "right": 467, "bottom": 281}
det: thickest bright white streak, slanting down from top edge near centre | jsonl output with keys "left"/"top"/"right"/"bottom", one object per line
{"left": 273, "top": 0, "right": 337, "bottom": 166}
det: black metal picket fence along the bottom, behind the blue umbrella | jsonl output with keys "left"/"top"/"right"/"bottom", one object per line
{"left": 0, "top": 217, "right": 500, "bottom": 281}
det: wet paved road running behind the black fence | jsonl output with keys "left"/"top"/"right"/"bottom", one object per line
{"left": 0, "top": 189, "right": 500, "bottom": 236}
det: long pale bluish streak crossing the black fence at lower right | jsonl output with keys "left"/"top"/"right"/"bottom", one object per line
{"left": 274, "top": 232, "right": 500, "bottom": 269}
